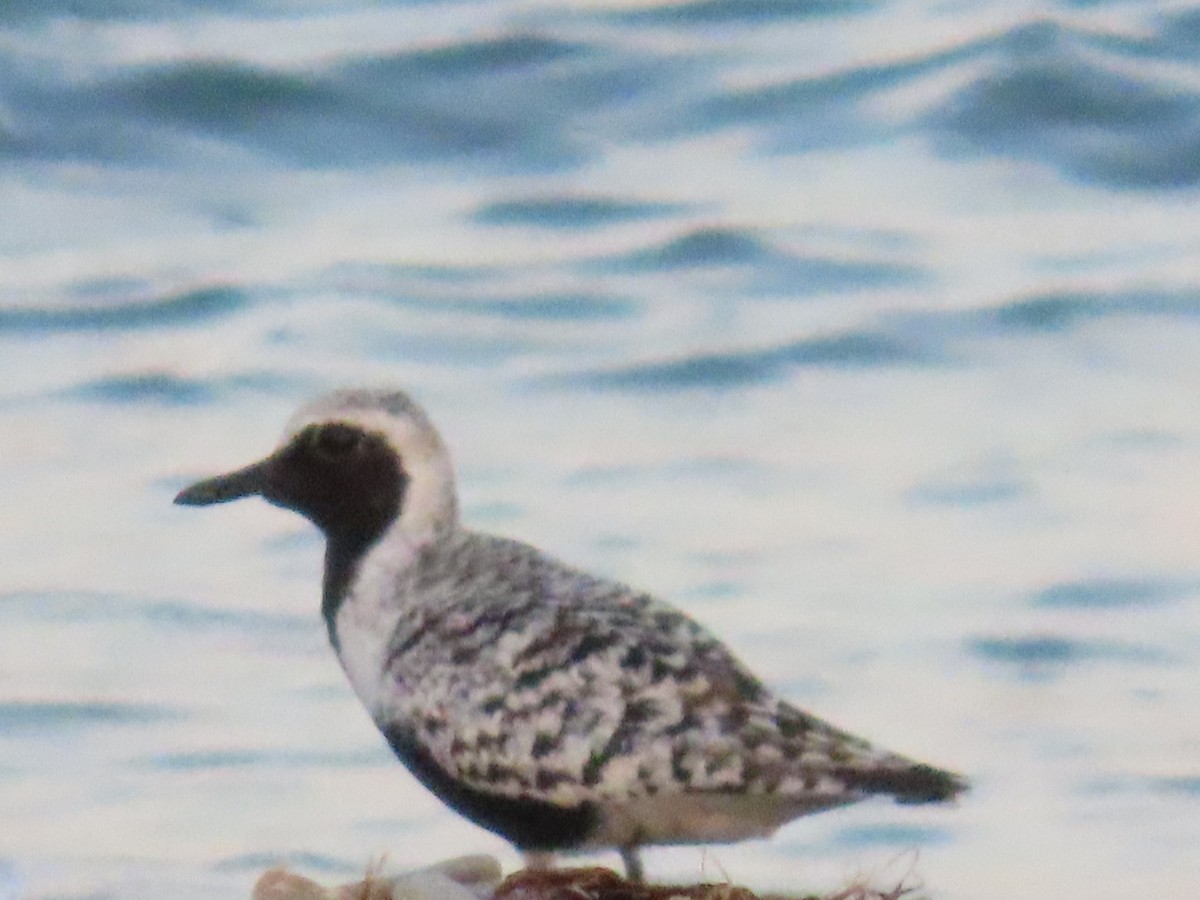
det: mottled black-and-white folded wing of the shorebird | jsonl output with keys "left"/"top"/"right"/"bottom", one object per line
{"left": 379, "top": 541, "right": 960, "bottom": 808}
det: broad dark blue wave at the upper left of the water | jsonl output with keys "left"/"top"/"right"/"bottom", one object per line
{"left": 7, "top": 34, "right": 657, "bottom": 170}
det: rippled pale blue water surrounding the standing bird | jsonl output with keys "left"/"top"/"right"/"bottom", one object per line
{"left": 0, "top": 0, "right": 1200, "bottom": 900}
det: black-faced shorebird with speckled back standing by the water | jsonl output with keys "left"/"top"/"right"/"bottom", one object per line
{"left": 175, "top": 388, "right": 967, "bottom": 881}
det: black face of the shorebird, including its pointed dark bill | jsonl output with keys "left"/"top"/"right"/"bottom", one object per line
{"left": 175, "top": 422, "right": 407, "bottom": 547}
